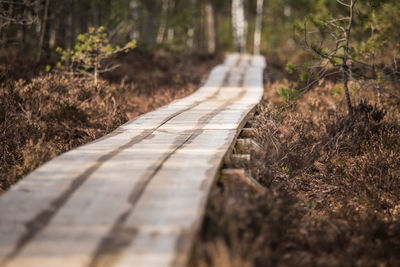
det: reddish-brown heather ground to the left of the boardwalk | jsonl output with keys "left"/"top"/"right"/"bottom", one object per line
{"left": 0, "top": 49, "right": 221, "bottom": 193}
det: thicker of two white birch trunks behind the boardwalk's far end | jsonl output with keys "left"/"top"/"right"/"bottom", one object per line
{"left": 232, "top": 0, "right": 246, "bottom": 53}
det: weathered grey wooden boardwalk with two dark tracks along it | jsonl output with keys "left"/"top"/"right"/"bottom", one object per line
{"left": 0, "top": 54, "right": 265, "bottom": 267}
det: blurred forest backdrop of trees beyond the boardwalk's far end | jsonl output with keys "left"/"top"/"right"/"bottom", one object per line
{"left": 0, "top": 0, "right": 400, "bottom": 69}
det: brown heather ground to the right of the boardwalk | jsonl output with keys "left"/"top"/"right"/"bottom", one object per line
{"left": 190, "top": 62, "right": 400, "bottom": 267}
